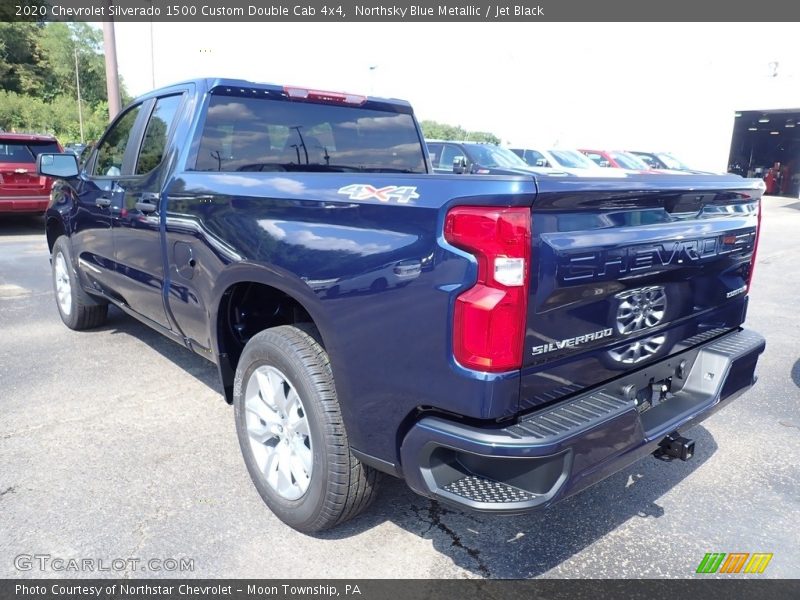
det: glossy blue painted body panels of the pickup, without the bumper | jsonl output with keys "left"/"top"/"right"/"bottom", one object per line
{"left": 42, "top": 80, "right": 761, "bottom": 478}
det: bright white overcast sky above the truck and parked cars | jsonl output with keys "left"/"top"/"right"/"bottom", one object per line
{"left": 108, "top": 22, "right": 800, "bottom": 169}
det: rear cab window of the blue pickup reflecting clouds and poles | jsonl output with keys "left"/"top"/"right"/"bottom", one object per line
{"left": 195, "top": 95, "right": 426, "bottom": 173}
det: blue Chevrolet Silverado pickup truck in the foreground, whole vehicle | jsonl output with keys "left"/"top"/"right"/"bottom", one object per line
{"left": 38, "top": 79, "right": 765, "bottom": 532}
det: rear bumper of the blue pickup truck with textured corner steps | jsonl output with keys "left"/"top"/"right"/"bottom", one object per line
{"left": 401, "top": 330, "right": 765, "bottom": 513}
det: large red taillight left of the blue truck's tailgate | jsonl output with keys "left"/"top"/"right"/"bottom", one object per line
{"left": 444, "top": 206, "right": 531, "bottom": 371}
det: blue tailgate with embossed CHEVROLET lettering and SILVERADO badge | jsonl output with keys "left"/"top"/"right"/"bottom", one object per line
{"left": 521, "top": 176, "right": 761, "bottom": 410}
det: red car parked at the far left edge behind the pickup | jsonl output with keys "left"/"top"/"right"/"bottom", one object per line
{"left": 0, "top": 132, "right": 62, "bottom": 214}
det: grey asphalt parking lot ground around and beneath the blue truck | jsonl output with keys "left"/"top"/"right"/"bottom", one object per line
{"left": 0, "top": 197, "right": 800, "bottom": 578}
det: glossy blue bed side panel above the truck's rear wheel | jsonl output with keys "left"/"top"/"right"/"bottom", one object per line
{"left": 165, "top": 172, "right": 535, "bottom": 462}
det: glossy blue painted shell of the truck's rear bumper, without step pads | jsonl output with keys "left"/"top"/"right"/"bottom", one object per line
{"left": 401, "top": 331, "right": 765, "bottom": 513}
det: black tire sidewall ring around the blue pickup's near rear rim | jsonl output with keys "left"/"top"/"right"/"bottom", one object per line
{"left": 233, "top": 331, "right": 330, "bottom": 530}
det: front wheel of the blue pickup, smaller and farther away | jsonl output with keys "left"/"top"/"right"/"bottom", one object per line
{"left": 51, "top": 235, "right": 108, "bottom": 331}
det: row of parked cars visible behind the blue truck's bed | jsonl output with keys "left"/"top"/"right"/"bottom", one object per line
{"left": 427, "top": 140, "right": 698, "bottom": 177}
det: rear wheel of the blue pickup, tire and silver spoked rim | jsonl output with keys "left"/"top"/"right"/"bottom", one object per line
{"left": 233, "top": 325, "right": 379, "bottom": 533}
